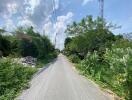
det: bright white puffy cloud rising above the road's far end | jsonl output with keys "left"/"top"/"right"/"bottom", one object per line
{"left": 43, "top": 12, "right": 73, "bottom": 49}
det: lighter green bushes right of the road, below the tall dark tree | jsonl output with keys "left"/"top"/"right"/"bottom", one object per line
{"left": 77, "top": 48, "right": 132, "bottom": 100}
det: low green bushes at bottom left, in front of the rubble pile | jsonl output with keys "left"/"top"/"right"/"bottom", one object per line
{"left": 0, "top": 58, "right": 37, "bottom": 100}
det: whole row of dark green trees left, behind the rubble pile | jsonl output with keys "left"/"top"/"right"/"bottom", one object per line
{"left": 0, "top": 27, "right": 55, "bottom": 58}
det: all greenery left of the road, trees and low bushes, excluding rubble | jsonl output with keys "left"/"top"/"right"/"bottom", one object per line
{"left": 0, "top": 27, "right": 57, "bottom": 100}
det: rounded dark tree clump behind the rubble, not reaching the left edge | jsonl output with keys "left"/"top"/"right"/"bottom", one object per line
{"left": 12, "top": 27, "right": 55, "bottom": 58}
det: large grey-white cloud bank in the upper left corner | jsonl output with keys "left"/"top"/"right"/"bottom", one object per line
{"left": 0, "top": 0, "right": 55, "bottom": 27}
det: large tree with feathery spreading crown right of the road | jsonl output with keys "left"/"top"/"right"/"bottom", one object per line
{"left": 65, "top": 16, "right": 116, "bottom": 59}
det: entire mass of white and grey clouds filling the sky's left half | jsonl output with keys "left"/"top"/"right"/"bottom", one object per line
{"left": 0, "top": 0, "right": 68, "bottom": 48}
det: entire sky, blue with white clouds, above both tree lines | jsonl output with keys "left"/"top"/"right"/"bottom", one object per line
{"left": 0, "top": 0, "right": 132, "bottom": 48}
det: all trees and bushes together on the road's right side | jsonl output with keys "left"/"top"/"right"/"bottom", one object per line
{"left": 64, "top": 16, "right": 132, "bottom": 100}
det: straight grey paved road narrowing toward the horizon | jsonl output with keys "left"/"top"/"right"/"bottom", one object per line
{"left": 18, "top": 55, "right": 112, "bottom": 100}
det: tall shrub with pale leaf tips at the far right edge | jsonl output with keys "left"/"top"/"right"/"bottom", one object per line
{"left": 104, "top": 48, "right": 132, "bottom": 100}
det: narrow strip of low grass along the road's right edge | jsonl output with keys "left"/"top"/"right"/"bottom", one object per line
{"left": 68, "top": 57, "right": 125, "bottom": 100}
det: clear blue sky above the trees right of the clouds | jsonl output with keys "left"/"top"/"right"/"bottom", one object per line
{"left": 58, "top": 0, "right": 132, "bottom": 34}
